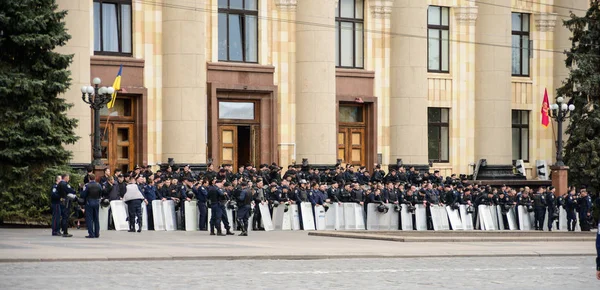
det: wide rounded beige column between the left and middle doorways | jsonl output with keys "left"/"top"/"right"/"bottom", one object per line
{"left": 161, "top": 0, "right": 208, "bottom": 163}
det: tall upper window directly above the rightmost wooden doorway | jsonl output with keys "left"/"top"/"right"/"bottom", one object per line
{"left": 335, "top": 0, "right": 365, "bottom": 68}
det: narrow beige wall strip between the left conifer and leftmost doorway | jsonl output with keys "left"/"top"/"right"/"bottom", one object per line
{"left": 57, "top": 0, "right": 92, "bottom": 163}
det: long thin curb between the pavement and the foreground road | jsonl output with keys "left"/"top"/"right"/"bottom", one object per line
{"left": 0, "top": 253, "right": 596, "bottom": 264}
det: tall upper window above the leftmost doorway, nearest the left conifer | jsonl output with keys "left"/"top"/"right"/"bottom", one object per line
{"left": 94, "top": 0, "right": 131, "bottom": 55}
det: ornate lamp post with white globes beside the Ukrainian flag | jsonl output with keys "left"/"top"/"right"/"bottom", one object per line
{"left": 81, "top": 78, "right": 115, "bottom": 166}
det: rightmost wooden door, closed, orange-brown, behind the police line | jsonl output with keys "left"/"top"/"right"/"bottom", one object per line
{"left": 338, "top": 127, "right": 366, "bottom": 166}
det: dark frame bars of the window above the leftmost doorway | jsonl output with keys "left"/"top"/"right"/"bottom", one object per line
{"left": 92, "top": 0, "right": 134, "bottom": 56}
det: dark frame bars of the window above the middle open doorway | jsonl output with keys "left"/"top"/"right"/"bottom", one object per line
{"left": 217, "top": 0, "right": 260, "bottom": 63}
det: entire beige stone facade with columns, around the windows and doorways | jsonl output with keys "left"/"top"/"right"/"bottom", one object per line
{"left": 58, "top": 0, "right": 587, "bottom": 178}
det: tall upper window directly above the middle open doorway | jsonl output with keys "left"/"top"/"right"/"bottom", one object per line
{"left": 219, "top": 0, "right": 258, "bottom": 62}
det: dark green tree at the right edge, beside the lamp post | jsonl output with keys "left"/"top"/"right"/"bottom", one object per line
{"left": 557, "top": 0, "right": 600, "bottom": 190}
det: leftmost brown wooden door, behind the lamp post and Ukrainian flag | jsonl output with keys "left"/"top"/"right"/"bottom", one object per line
{"left": 101, "top": 123, "right": 135, "bottom": 172}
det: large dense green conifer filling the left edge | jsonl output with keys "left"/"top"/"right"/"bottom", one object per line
{"left": 0, "top": 0, "right": 78, "bottom": 221}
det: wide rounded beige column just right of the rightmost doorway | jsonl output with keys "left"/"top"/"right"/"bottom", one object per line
{"left": 389, "top": 1, "right": 428, "bottom": 165}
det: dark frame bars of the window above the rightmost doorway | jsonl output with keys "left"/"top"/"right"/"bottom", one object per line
{"left": 335, "top": 0, "right": 366, "bottom": 69}
